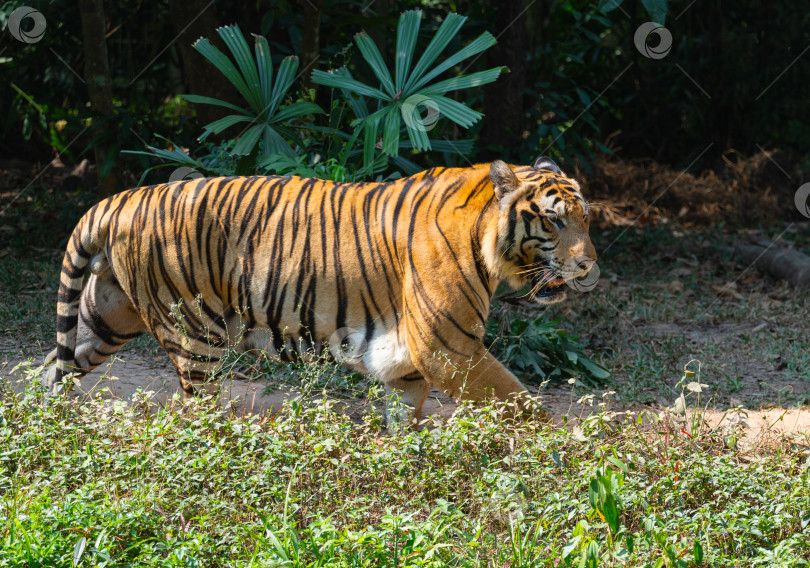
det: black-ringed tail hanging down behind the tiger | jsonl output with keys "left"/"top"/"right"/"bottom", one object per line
{"left": 46, "top": 207, "right": 106, "bottom": 394}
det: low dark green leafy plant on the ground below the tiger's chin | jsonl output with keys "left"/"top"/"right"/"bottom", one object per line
{"left": 485, "top": 315, "right": 610, "bottom": 384}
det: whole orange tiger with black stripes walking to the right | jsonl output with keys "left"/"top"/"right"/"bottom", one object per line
{"left": 46, "top": 156, "right": 596, "bottom": 422}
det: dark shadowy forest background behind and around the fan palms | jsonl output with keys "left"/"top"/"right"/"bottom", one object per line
{"left": 0, "top": 0, "right": 810, "bottom": 226}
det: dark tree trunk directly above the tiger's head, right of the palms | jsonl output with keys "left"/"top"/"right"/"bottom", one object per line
{"left": 480, "top": 0, "right": 529, "bottom": 160}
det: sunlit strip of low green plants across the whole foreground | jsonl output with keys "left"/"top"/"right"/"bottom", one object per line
{"left": 0, "top": 368, "right": 810, "bottom": 568}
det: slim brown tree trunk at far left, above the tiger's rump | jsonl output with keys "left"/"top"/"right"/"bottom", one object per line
{"left": 79, "top": 0, "right": 120, "bottom": 196}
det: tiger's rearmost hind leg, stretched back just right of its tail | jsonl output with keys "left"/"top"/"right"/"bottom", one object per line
{"left": 47, "top": 269, "right": 146, "bottom": 389}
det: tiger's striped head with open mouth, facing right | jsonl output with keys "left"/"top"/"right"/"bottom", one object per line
{"left": 484, "top": 156, "right": 596, "bottom": 304}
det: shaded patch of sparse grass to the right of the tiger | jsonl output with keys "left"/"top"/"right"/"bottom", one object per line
{"left": 544, "top": 220, "right": 810, "bottom": 407}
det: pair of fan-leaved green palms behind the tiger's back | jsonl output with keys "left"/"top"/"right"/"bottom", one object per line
{"left": 133, "top": 10, "right": 502, "bottom": 181}
